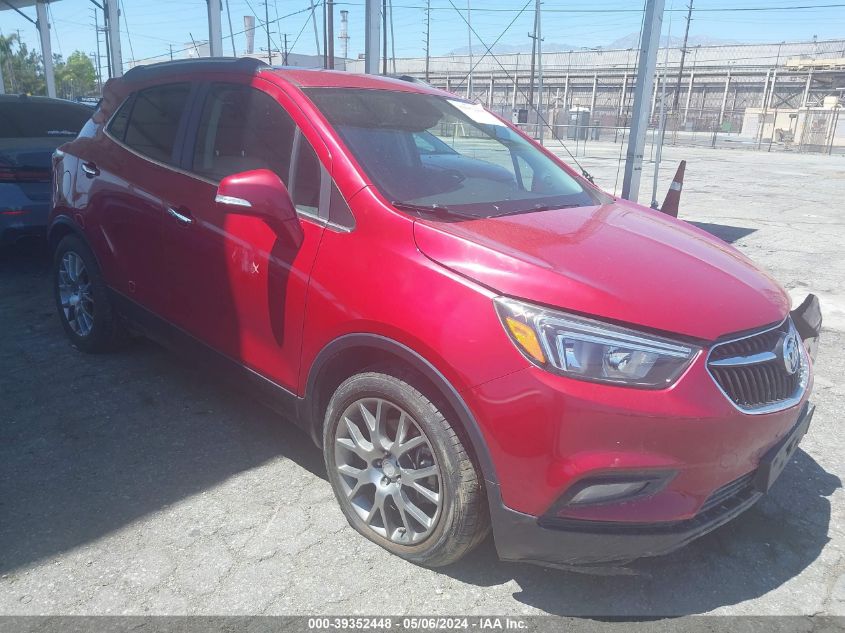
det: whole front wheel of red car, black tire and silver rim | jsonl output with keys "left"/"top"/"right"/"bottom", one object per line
{"left": 323, "top": 372, "right": 489, "bottom": 567}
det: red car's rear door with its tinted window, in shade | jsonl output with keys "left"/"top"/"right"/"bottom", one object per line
{"left": 76, "top": 82, "right": 196, "bottom": 315}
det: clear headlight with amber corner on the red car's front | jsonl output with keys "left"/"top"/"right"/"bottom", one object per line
{"left": 495, "top": 297, "right": 700, "bottom": 389}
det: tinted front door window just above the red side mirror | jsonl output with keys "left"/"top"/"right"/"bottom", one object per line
{"left": 193, "top": 84, "right": 296, "bottom": 181}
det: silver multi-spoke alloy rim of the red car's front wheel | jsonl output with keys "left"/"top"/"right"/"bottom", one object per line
{"left": 334, "top": 398, "right": 443, "bottom": 545}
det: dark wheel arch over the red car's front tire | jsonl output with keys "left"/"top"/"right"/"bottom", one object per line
{"left": 300, "top": 333, "right": 498, "bottom": 483}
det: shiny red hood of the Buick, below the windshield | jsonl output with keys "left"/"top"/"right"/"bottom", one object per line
{"left": 414, "top": 201, "right": 790, "bottom": 340}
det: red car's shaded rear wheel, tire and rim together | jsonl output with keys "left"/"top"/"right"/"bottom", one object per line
{"left": 53, "top": 235, "right": 127, "bottom": 354}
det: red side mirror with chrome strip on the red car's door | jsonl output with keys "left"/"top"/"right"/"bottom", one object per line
{"left": 214, "top": 169, "right": 296, "bottom": 222}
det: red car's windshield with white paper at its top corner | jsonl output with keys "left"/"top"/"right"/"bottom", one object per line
{"left": 308, "top": 88, "right": 605, "bottom": 217}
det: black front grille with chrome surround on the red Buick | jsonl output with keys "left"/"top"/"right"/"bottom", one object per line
{"left": 707, "top": 319, "right": 806, "bottom": 413}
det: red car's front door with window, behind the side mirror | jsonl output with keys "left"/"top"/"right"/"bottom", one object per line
{"left": 157, "top": 77, "right": 330, "bottom": 391}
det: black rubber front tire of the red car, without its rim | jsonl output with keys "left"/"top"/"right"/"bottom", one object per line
{"left": 323, "top": 372, "right": 490, "bottom": 567}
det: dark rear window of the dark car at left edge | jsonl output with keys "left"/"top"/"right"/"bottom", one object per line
{"left": 0, "top": 98, "right": 94, "bottom": 138}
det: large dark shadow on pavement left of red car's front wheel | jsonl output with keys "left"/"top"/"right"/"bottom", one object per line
{"left": 0, "top": 244, "right": 325, "bottom": 572}
